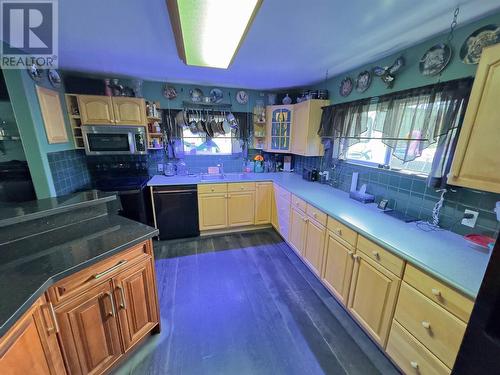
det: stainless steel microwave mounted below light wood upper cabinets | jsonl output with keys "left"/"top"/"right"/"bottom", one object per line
{"left": 82, "top": 126, "right": 140, "bottom": 155}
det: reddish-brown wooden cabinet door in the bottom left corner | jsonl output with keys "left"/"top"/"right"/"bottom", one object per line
{"left": 0, "top": 297, "right": 66, "bottom": 375}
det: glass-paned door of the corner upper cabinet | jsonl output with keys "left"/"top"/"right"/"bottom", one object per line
{"left": 266, "top": 105, "right": 293, "bottom": 153}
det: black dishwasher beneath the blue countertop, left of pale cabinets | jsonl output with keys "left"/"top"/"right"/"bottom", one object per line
{"left": 153, "top": 185, "right": 200, "bottom": 240}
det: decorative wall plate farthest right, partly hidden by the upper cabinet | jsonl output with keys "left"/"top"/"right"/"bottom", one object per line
{"left": 460, "top": 25, "right": 500, "bottom": 64}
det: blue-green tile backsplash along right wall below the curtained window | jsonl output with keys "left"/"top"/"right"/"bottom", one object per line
{"left": 294, "top": 156, "right": 500, "bottom": 237}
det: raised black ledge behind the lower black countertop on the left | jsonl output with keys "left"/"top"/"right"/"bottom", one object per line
{"left": 0, "top": 190, "right": 116, "bottom": 228}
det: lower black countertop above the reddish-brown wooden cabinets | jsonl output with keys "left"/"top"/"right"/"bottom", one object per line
{"left": 0, "top": 214, "right": 158, "bottom": 337}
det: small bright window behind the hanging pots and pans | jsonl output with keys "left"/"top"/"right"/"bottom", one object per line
{"left": 182, "top": 127, "right": 241, "bottom": 155}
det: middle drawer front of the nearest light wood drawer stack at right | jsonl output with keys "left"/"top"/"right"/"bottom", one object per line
{"left": 394, "top": 282, "right": 466, "bottom": 368}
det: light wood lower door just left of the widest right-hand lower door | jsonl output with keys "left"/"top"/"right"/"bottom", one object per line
{"left": 322, "top": 234, "right": 354, "bottom": 305}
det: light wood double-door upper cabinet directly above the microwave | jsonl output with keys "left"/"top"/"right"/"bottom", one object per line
{"left": 78, "top": 95, "right": 147, "bottom": 125}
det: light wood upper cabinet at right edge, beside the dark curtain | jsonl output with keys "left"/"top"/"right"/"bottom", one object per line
{"left": 448, "top": 44, "right": 500, "bottom": 193}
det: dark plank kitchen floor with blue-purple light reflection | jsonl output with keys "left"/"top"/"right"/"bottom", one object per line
{"left": 112, "top": 230, "right": 398, "bottom": 375}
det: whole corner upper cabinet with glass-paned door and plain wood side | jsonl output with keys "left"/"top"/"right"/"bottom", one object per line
{"left": 266, "top": 99, "right": 329, "bottom": 156}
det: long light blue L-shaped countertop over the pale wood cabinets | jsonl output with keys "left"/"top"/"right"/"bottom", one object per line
{"left": 148, "top": 172, "right": 490, "bottom": 299}
